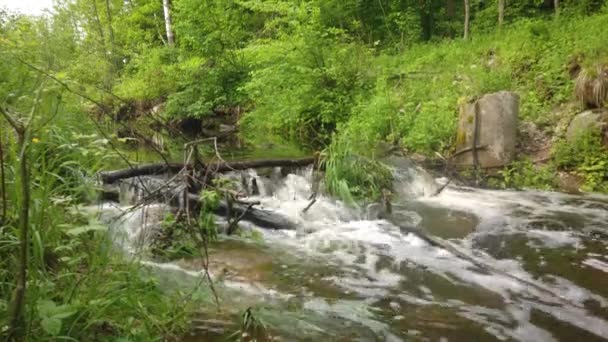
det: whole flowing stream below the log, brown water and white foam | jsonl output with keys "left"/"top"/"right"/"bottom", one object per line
{"left": 96, "top": 165, "right": 608, "bottom": 341}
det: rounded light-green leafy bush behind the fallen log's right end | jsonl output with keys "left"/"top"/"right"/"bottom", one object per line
{"left": 243, "top": 8, "right": 371, "bottom": 145}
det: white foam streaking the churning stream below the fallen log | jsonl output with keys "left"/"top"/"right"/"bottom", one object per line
{"left": 101, "top": 169, "right": 608, "bottom": 341}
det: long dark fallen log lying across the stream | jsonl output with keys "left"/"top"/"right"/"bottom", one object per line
{"left": 99, "top": 157, "right": 317, "bottom": 184}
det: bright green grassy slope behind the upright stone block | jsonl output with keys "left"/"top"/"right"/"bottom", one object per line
{"left": 340, "top": 14, "right": 608, "bottom": 154}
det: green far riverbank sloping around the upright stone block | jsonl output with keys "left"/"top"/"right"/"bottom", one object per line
{"left": 115, "top": 12, "right": 608, "bottom": 195}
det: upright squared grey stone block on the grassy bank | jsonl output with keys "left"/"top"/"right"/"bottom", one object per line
{"left": 454, "top": 91, "right": 519, "bottom": 168}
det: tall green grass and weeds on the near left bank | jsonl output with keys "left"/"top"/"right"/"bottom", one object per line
{"left": 0, "top": 108, "right": 204, "bottom": 340}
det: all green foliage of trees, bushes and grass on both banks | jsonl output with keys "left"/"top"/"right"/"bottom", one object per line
{"left": 0, "top": 0, "right": 608, "bottom": 340}
